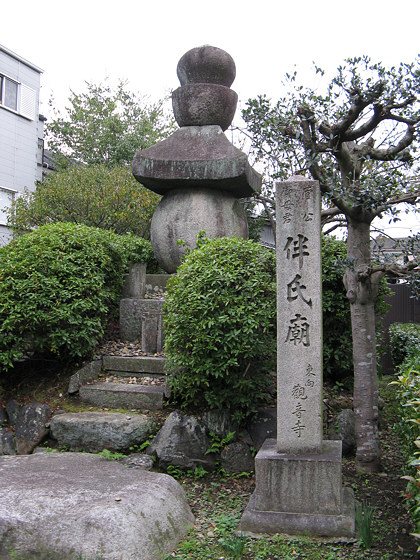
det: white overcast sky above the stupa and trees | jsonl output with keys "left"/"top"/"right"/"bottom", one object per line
{"left": 0, "top": 0, "right": 420, "bottom": 236}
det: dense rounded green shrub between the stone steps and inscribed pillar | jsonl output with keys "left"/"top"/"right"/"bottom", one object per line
{"left": 164, "top": 234, "right": 276, "bottom": 419}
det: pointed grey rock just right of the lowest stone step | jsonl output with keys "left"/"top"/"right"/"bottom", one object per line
{"left": 147, "top": 412, "right": 216, "bottom": 470}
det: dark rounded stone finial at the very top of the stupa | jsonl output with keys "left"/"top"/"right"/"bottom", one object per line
{"left": 176, "top": 45, "right": 236, "bottom": 87}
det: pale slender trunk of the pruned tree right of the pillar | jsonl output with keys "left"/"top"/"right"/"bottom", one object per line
{"left": 344, "top": 218, "right": 380, "bottom": 472}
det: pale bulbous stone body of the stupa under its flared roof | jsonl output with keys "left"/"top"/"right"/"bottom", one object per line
{"left": 151, "top": 188, "right": 248, "bottom": 272}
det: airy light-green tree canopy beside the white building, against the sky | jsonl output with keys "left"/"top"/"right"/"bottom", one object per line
{"left": 46, "top": 81, "right": 173, "bottom": 167}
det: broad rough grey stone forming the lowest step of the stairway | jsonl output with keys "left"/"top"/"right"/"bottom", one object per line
{"left": 50, "top": 412, "right": 156, "bottom": 451}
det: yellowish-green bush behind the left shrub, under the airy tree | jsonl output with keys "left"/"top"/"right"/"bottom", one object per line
{"left": 8, "top": 165, "right": 160, "bottom": 237}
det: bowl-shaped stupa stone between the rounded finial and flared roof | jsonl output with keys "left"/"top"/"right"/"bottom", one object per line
{"left": 172, "top": 83, "right": 238, "bottom": 130}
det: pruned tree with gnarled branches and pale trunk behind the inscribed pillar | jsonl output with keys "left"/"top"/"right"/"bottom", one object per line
{"left": 243, "top": 57, "right": 420, "bottom": 472}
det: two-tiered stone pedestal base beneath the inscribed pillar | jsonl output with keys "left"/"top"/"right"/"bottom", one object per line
{"left": 239, "top": 439, "right": 355, "bottom": 537}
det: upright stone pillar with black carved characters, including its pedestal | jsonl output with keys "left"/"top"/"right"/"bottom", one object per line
{"left": 240, "top": 177, "right": 355, "bottom": 537}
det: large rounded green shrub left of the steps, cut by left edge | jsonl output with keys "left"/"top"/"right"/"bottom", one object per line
{"left": 0, "top": 223, "right": 151, "bottom": 369}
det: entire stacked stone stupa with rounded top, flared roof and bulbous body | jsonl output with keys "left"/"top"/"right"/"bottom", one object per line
{"left": 133, "top": 46, "right": 261, "bottom": 273}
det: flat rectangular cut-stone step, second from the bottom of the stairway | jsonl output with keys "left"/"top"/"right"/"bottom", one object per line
{"left": 79, "top": 382, "right": 165, "bottom": 410}
